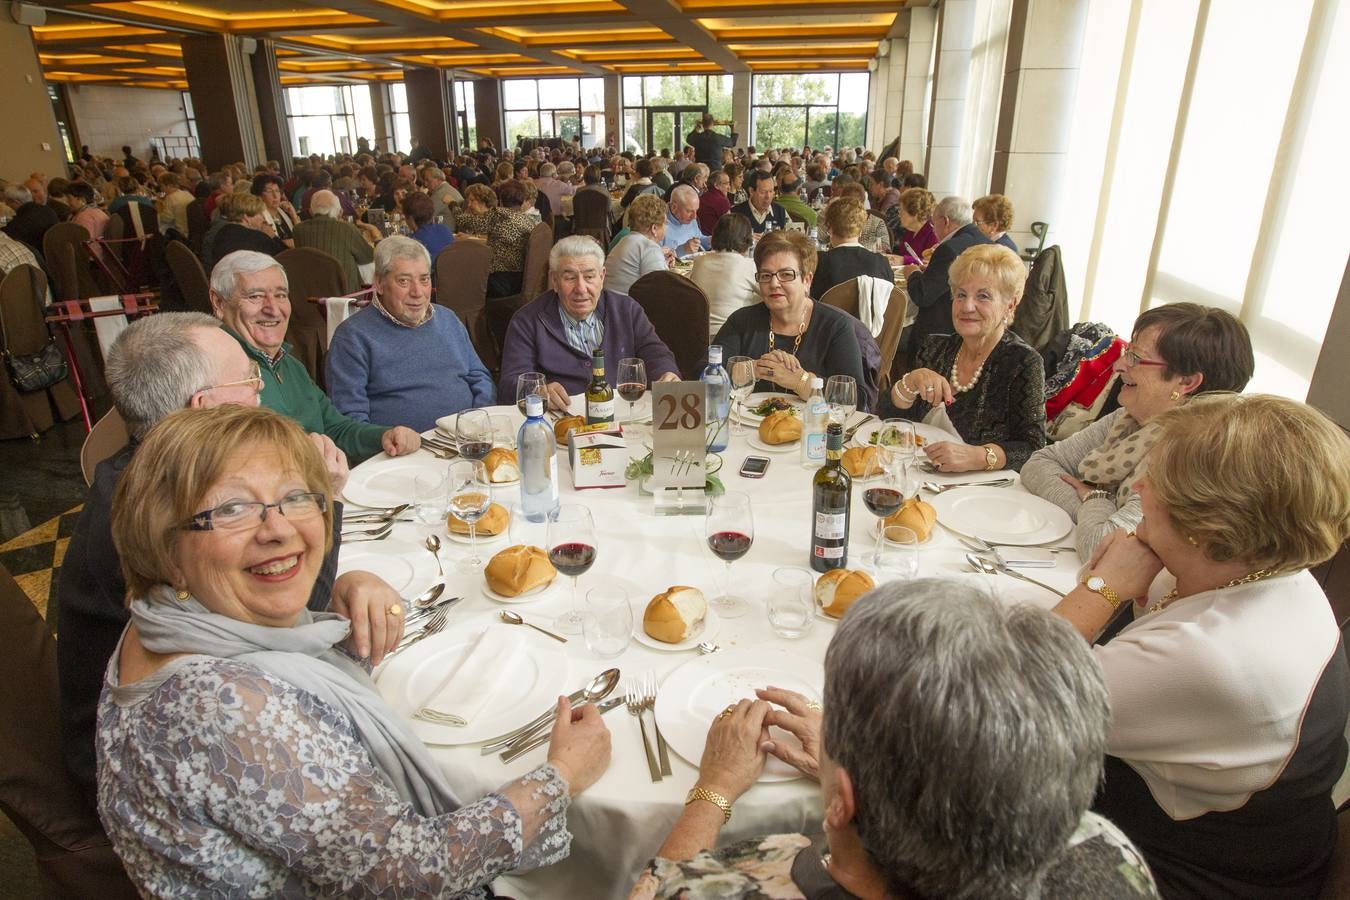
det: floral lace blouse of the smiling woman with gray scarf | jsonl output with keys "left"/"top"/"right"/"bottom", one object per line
{"left": 97, "top": 656, "right": 571, "bottom": 897}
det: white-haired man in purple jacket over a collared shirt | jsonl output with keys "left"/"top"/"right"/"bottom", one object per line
{"left": 498, "top": 235, "right": 679, "bottom": 410}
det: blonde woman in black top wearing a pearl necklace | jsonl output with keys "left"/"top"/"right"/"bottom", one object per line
{"left": 891, "top": 244, "right": 1045, "bottom": 472}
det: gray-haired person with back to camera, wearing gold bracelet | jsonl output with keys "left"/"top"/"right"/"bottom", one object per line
{"left": 633, "top": 579, "right": 1158, "bottom": 900}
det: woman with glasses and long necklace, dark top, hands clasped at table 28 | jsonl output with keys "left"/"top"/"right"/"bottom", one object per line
{"left": 713, "top": 231, "right": 880, "bottom": 409}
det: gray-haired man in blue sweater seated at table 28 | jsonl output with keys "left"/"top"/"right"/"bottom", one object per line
{"left": 328, "top": 235, "right": 497, "bottom": 432}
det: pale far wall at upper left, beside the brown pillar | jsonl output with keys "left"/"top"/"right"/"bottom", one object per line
{"left": 70, "top": 85, "right": 188, "bottom": 159}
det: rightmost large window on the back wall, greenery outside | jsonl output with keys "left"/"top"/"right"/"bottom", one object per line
{"left": 751, "top": 72, "right": 868, "bottom": 150}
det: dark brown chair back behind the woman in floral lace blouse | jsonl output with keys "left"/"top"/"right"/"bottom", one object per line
{"left": 0, "top": 565, "right": 136, "bottom": 900}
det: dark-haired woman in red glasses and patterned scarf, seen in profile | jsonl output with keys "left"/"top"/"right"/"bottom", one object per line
{"left": 1022, "top": 304, "right": 1256, "bottom": 560}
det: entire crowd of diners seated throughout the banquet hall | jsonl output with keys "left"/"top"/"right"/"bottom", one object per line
{"left": 13, "top": 135, "right": 1350, "bottom": 899}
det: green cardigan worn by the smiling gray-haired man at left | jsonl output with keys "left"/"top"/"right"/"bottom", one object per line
{"left": 224, "top": 328, "right": 386, "bottom": 466}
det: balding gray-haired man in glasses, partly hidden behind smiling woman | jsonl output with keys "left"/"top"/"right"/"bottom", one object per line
{"left": 57, "top": 313, "right": 402, "bottom": 806}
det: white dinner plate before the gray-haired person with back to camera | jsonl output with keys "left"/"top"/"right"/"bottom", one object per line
{"left": 653, "top": 644, "right": 825, "bottom": 781}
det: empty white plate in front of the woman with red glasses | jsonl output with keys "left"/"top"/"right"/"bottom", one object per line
{"left": 929, "top": 486, "right": 1073, "bottom": 546}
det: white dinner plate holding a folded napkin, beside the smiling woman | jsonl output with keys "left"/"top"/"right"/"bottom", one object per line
{"left": 375, "top": 613, "right": 567, "bottom": 746}
